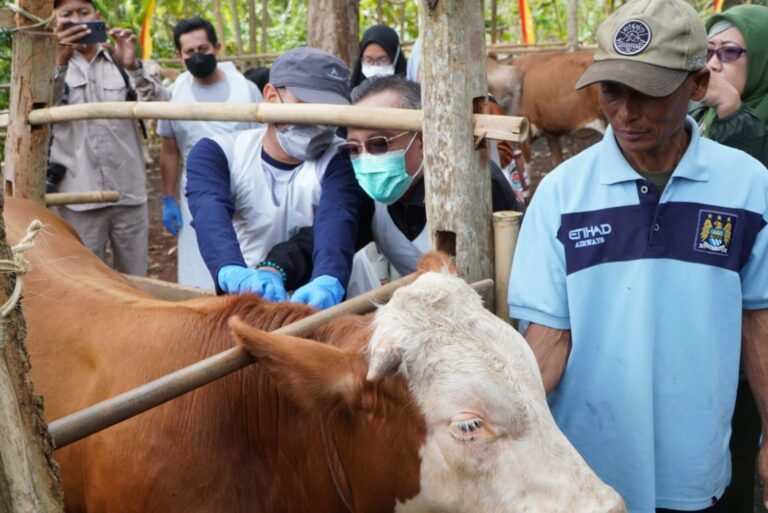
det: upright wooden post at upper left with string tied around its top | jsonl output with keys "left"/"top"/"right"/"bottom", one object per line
{"left": 4, "top": 0, "right": 55, "bottom": 203}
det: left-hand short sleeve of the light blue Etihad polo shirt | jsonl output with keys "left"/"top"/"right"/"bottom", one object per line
{"left": 508, "top": 179, "right": 571, "bottom": 330}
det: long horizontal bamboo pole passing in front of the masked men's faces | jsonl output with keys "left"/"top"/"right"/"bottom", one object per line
{"left": 24, "top": 102, "right": 528, "bottom": 144}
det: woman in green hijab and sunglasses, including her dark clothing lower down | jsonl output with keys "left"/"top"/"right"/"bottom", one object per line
{"left": 691, "top": 5, "right": 768, "bottom": 513}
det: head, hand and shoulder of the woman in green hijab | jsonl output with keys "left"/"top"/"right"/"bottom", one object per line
{"left": 691, "top": 5, "right": 768, "bottom": 167}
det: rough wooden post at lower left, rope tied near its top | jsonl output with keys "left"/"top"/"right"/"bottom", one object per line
{"left": 0, "top": 195, "right": 64, "bottom": 513}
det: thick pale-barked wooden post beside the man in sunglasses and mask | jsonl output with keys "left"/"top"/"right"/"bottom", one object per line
{"left": 419, "top": 0, "right": 493, "bottom": 306}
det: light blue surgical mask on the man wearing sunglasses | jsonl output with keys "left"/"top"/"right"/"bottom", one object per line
{"left": 352, "top": 134, "right": 424, "bottom": 205}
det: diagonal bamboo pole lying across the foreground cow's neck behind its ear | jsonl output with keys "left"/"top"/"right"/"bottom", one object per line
{"left": 48, "top": 272, "right": 493, "bottom": 449}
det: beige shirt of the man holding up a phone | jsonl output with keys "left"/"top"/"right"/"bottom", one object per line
{"left": 50, "top": 48, "right": 170, "bottom": 211}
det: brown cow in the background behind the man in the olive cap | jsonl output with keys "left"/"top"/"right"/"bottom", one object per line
{"left": 487, "top": 50, "right": 606, "bottom": 165}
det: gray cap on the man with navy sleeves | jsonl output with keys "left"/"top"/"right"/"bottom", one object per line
{"left": 269, "top": 46, "right": 350, "bottom": 105}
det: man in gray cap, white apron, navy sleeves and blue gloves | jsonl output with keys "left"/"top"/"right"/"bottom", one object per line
{"left": 186, "top": 48, "right": 361, "bottom": 308}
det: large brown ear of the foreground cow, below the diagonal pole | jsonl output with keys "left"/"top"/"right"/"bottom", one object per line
{"left": 229, "top": 317, "right": 365, "bottom": 409}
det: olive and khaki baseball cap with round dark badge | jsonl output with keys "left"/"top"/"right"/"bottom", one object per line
{"left": 576, "top": 0, "right": 707, "bottom": 97}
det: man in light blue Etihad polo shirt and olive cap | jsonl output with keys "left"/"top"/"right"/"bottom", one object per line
{"left": 509, "top": 0, "right": 768, "bottom": 513}
